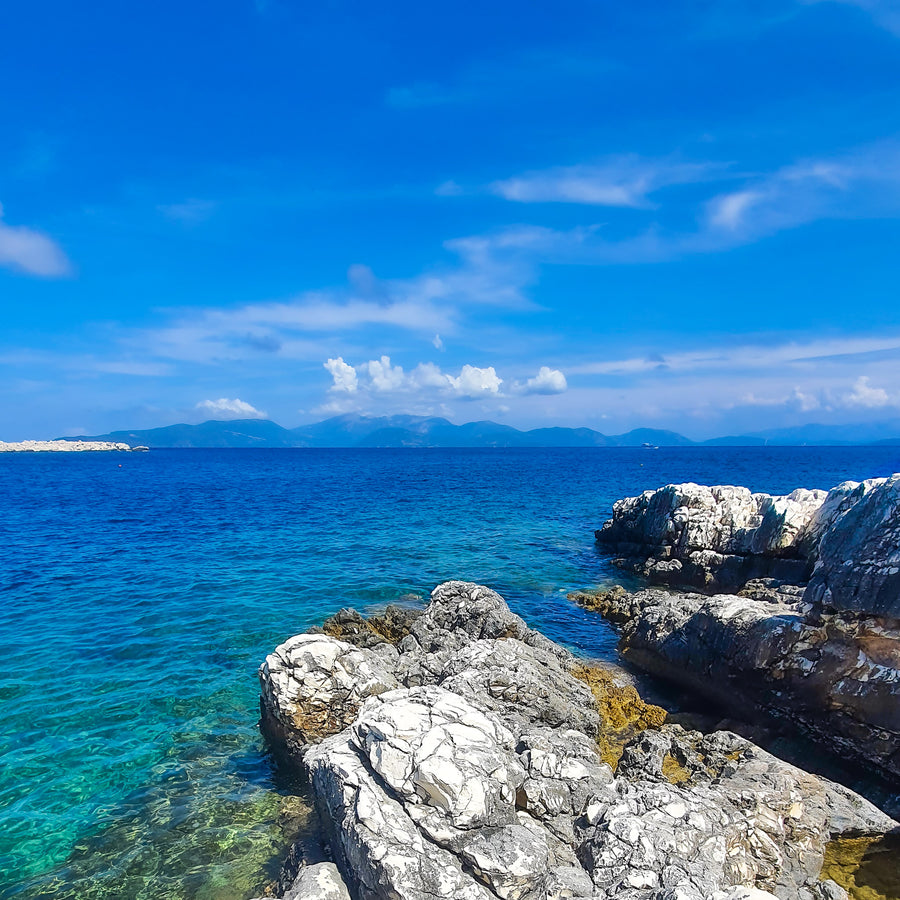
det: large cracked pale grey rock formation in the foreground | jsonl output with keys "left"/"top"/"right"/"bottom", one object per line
{"left": 251, "top": 582, "right": 896, "bottom": 900}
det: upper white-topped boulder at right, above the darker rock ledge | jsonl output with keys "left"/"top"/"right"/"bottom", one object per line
{"left": 595, "top": 474, "right": 900, "bottom": 620}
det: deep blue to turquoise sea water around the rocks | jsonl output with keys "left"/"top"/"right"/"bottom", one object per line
{"left": 0, "top": 448, "right": 900, "bottom": 900}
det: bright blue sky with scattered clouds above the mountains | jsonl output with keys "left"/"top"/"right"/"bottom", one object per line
{"left": 0, "top": 0, "right": 900, "bottom": 440}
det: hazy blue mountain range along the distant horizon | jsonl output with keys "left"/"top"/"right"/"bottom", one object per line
{"left": 68, "top": 413, "right": 900, "bottom": 448}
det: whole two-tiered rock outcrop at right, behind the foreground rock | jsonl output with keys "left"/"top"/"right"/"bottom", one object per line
{"left": 584, "top": 475, "right": 900, "bottom": 779}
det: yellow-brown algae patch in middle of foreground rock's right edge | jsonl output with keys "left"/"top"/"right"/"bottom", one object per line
{"left": 572, "top": 664, "right": 666, "bottom": 771}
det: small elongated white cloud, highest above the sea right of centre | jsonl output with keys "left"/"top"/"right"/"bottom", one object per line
{"left": 490, "top": 156, "right": 721, "bottom": 207}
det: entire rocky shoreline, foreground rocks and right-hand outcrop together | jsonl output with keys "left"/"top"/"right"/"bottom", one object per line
{"left": 251, "top": 475, "right": 900, "bottom": 900}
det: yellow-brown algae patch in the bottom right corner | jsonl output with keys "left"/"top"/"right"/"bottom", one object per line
{"left": 819, "top": 834, "right": 900, "bottom": 900}
